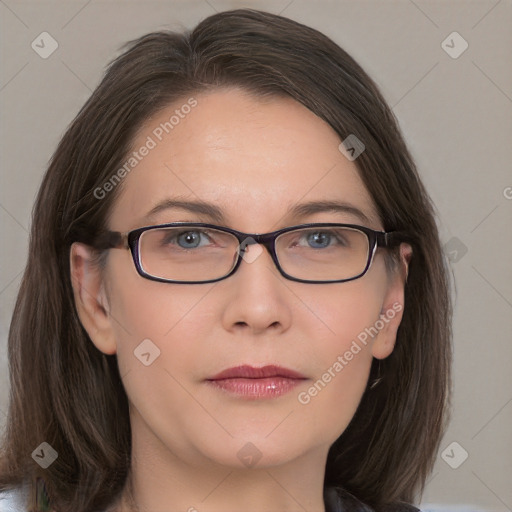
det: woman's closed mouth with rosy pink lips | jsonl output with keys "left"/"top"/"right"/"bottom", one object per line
{"left": 206, "top": 365, "right": 307, "bottom": 400}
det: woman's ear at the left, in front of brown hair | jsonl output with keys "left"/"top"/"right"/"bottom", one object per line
{"left": 69, "top": 242, "right": 117, "bottom": 354}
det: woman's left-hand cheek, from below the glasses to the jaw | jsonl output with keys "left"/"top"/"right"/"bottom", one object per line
{"left": 106, "top": 277, "right": 216, "bottom": 450}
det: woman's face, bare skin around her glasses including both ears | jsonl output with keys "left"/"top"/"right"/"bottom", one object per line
{"left": 71, "top": 89, "right": 403, "bottom": 476}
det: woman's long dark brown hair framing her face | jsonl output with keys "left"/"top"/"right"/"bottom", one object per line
{"left": 0, "top": 9, "right": 452, "bottom": 512}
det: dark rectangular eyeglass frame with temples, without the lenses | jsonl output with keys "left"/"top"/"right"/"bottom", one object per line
{"left": 94, "top": 222, "right": 408, "bottom": 284}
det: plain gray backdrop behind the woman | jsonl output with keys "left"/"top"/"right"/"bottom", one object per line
{"left": 0, "top": 0, "right": 512, "bottom": 511}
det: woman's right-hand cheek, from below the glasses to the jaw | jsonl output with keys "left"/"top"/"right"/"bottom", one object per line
{"left": 297, "top": 279, "right": 384, "bottom": 442}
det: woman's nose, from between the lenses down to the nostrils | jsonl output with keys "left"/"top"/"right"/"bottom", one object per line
{"left": 219, "top": 241, "right": 292, "bottom": 334}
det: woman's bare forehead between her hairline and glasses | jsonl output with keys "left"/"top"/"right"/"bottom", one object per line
{"left": 111, "top": 89, "right": 380, "bottom": 232}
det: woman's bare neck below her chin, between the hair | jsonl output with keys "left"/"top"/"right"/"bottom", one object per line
{"left": 114, "top": 446, "right": 325, "bottom": 512}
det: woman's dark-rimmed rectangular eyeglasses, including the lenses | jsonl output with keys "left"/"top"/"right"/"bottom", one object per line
{"left": 96, "top": 222, "right": 403, "bottom": 284}
